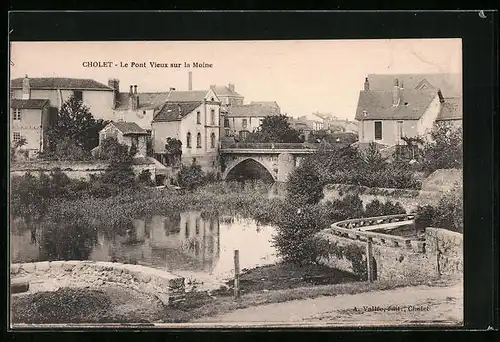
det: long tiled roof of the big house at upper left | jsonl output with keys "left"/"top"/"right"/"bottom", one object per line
{"left": 10, "top": 77, "right": 113, "bottom": 91}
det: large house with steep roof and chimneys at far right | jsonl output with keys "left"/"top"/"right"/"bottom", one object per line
{"left": 356, "top": 74, "right": 462, "bottom": 146}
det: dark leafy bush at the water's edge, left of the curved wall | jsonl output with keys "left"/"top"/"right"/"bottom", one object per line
{"left": 273, "top": 204, "right": 328, "bottom": 265}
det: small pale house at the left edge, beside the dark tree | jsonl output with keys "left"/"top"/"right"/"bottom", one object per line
{"left": 10, "top": 98, "right": 50, "bottom": 158}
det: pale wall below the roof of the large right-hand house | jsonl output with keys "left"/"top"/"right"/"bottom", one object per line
{"left": 358, "top": 120, "right": 419, "bottom": 145}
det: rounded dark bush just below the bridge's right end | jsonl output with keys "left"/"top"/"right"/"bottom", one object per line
{"left": 287, "top": 164, "right": 323, "bottom": 206}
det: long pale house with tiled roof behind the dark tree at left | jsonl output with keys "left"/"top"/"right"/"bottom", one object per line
{"left": 10, "top": 75, "right": 114, "bottom": 120}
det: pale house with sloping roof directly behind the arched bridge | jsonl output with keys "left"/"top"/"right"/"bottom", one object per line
{"left": 224, "top": 104, "right": 280, "bottom": 140}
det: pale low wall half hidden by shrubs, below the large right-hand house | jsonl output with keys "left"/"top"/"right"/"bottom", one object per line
{"left": 323, "top": 184, "right": 442, "bottom": 212}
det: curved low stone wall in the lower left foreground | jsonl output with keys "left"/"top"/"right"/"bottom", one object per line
{"left": 10, "top": 261, "right": 185, "bottom": 305}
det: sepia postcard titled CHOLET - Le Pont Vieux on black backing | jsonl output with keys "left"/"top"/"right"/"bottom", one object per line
{"left": 8, "top": 38, "right": 464, "bottom": 329}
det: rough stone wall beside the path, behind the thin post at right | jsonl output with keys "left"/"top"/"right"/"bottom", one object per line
{"left": 318, "top": 228, "right": 463, "bottom": 280}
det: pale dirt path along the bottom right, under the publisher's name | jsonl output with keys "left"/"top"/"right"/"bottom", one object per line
{"left": 198, "top": 283, "right": 463, "bottom": 326}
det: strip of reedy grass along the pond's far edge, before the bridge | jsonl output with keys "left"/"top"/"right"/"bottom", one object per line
{"left": 47, "top": 183, "right": 283, "bottom": 228}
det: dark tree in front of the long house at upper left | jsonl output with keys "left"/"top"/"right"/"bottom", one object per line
{"left": 47, "top": 96, "right": 108, "bottom": 156}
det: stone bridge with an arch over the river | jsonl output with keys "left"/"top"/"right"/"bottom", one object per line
{"left": 219, "top": 143, "right": 317, "bottom": 182}
